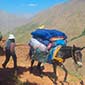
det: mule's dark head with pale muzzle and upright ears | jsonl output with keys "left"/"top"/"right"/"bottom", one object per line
{"left": 72, "top": 45, "right": 83, "bottom": 67}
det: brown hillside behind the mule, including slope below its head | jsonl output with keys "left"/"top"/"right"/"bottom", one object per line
{"left": 13, "top": 0, "right": 85, "bottom": 82}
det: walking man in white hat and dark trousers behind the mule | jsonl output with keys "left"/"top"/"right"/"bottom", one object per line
{"left": 2, "top": 34, "right": 17, "bottom": 69}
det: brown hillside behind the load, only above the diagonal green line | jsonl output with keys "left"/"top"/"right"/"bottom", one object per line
{"left": 16, "top": 0, "right": 85, "bottom": 42}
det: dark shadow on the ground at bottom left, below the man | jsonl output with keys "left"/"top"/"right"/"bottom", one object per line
{"left": 0, "top": 67, "right": 37, "bottom": 85}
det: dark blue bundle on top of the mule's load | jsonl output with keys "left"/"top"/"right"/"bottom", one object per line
{"left": 31, "top": 29, "right": 67, "bottom": 40}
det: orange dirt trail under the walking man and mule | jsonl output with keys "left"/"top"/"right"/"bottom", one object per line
{"left": 0, "top": 45, "right": 85, "bottom": 85}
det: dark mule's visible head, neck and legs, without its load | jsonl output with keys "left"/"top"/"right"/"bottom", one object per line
{"left": 29, "top": 45, "right": 85, "bottom": 83}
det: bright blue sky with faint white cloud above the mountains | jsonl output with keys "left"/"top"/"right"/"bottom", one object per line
{"left": 0, "top": 0, "right": 68, "bottom": 14}
